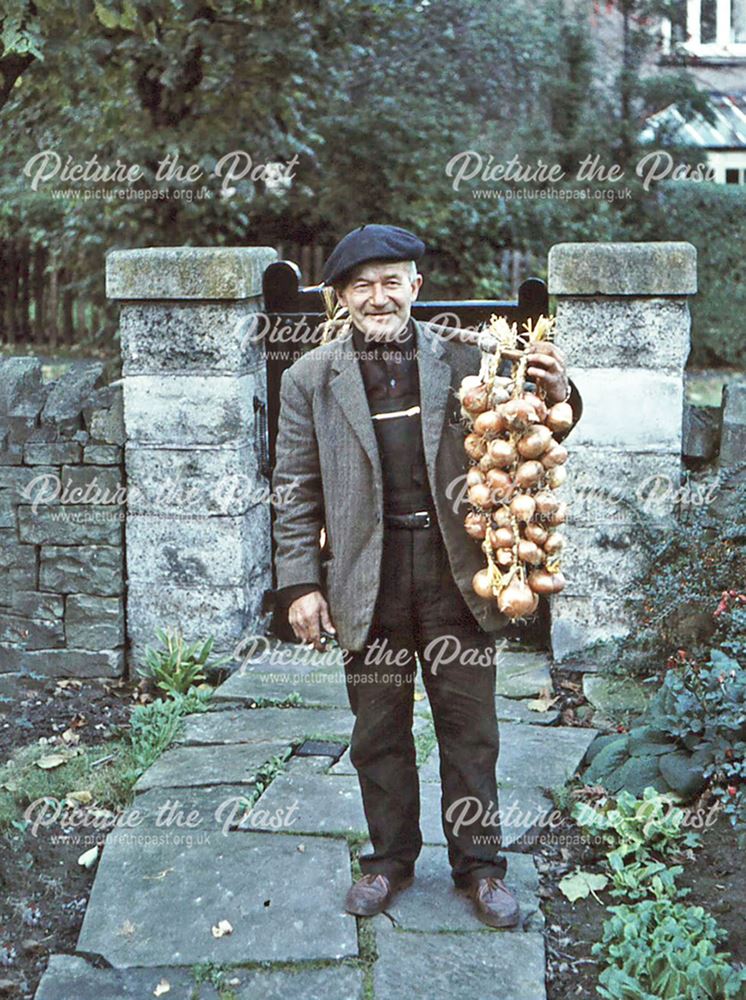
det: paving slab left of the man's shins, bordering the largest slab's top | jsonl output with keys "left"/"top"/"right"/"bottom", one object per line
{"left": 235, "top": 768, "right": 368, "bottom": 835}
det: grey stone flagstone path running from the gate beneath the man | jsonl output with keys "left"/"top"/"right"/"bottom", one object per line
{"left": 36, "top": 646, "right": 596, "bottom": 1000}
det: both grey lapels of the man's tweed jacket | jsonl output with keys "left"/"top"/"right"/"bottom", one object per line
{"left": 331, "top": 319, "right": 451, "bottom": 488}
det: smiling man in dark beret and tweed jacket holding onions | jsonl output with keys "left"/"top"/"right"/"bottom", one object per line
{"left": 273, "top": 225, "right": 582, "bottom": 927}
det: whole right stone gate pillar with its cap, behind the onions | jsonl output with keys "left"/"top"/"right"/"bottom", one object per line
{"left": 549, "top": 243, "right": 697, "bottom": 660}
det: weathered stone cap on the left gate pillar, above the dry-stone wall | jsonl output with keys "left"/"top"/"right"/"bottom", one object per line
{"left": 106, "top": 247, "right": 277, "bottom": 301}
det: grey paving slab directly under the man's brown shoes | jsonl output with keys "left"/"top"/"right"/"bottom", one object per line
{"left": 370, "top": 843, "right": 544, "bottom": 934}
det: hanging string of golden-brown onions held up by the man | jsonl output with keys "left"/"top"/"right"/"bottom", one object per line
{"left": 459, "top": 316, "right": 573, "bottom": 619}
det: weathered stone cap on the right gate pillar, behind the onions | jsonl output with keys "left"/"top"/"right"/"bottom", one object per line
{"left": 548, "top": 242, "right": 697, "bottom": 295}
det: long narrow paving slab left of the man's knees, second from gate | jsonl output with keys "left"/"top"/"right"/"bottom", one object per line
{"left": 175, "top": 708, "right": 355, "bottom": 745}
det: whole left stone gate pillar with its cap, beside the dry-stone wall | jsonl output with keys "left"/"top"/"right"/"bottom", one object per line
{"left": 106, "top": 247, "right": 276, "bottom": 669}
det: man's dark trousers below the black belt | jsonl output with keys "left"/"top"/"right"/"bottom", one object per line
{"left": 343, "top": 522, "right": 507, "bottom": 886}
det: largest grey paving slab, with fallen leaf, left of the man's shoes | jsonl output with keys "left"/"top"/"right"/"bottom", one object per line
{"left": 77, "top": 830, "right": 357, "bottom": 968}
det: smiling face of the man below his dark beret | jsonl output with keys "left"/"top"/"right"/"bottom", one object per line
{"left": 337, "top": 260, "right": 422, "bottom": 340}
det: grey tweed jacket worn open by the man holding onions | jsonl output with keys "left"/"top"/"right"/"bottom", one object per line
{"left": 272, "top": 320, "right": 581, "bottom": 650}
